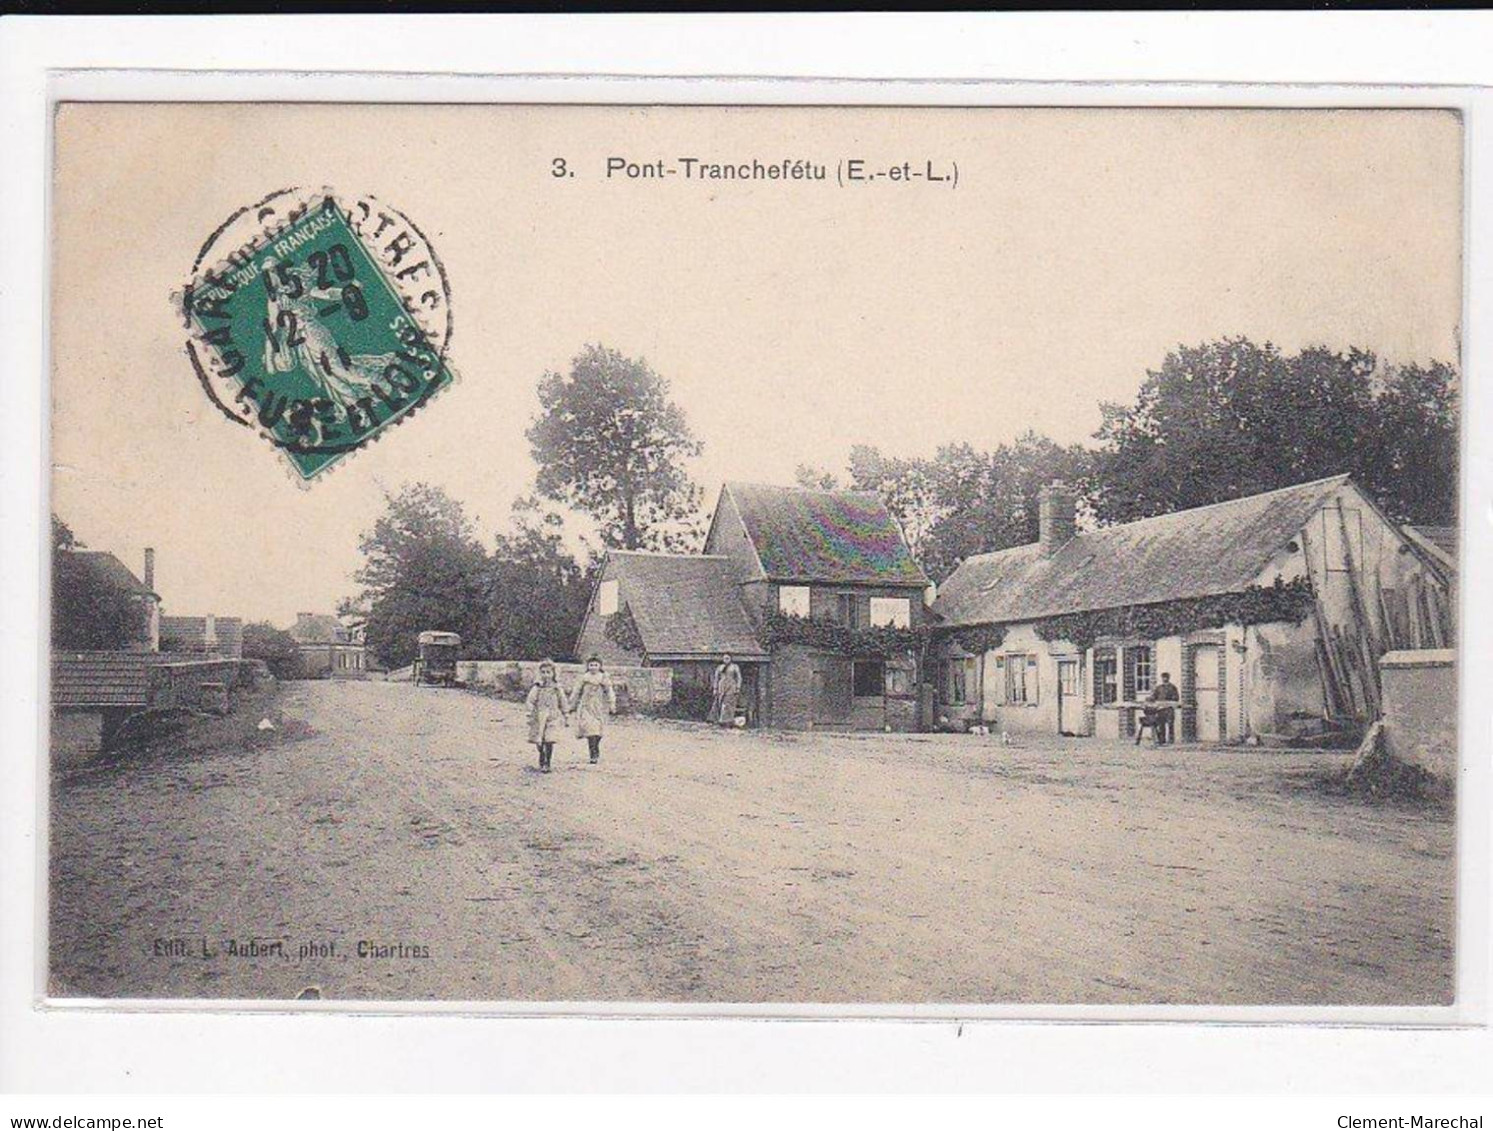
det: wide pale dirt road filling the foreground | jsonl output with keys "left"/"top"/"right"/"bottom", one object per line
{"left": 51, "top": 682, "right": 1454, "bottom": 1004}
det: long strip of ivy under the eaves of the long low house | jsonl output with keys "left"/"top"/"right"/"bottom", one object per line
{"left": 1033, "top": 577, "right": 1315, "bottom": 649}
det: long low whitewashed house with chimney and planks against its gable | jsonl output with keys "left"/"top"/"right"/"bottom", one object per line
{"left": 933, "top": 476, "right": 1456, "bottom": 742}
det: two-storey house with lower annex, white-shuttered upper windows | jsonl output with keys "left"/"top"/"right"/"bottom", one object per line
{"left": 578, "top": 483, "right": 929, "bottom": 731}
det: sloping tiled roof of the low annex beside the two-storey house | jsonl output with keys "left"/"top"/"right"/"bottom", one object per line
{"left": 603, "top": 551, "right": 767, "bottom": 660}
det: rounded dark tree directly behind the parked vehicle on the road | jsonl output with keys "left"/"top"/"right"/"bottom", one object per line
{"left": 349, "top": 483, "right": 488, "bottom": 668}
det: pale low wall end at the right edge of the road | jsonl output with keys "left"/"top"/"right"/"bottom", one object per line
{"left": 1380, "top": 648, "right": 1457, "bottom": 785}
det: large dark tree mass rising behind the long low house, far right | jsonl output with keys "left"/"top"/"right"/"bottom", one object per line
{"left": 1091, "top": 337, "right": 1457, "bottom": 522}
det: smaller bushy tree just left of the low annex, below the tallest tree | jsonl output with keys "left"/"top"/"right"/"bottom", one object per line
{"left": 487, "top": 497, "right": 591, "bottom": 660}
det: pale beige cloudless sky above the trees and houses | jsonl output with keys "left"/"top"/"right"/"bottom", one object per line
{"left": 51, "top": 103, "right": 1462, "bottom": 624}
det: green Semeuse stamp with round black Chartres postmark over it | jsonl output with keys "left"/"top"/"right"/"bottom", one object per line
{"left": 179, "top": 188, "right": 455, "bottom": 479}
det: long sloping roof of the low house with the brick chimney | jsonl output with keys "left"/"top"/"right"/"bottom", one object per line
{"left": 933, "top": 474, "right": 1348, "bottom": 625}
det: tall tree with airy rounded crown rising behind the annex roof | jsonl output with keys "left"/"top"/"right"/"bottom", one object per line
{"left": 527, "top": 345, "right": 702, "bottom": 549}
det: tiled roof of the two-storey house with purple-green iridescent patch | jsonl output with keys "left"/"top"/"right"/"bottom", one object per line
{"left": 724, "top": 483, "right": 929, "bottom": 585}
